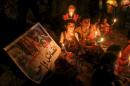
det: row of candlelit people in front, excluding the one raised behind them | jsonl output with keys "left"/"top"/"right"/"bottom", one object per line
{"left": 60, "top": 18, "right": 110, "bottom": 52}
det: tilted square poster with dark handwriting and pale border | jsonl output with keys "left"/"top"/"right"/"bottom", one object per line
{"left": 4, "top": 23, "right": 61, "bottom": 83}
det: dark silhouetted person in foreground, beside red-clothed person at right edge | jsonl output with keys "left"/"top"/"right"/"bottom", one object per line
{"left": 92, "top": 53, "right": 121, "bottom": 86}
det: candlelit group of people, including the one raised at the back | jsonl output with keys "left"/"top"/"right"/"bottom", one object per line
{"left": 60, "top": 5, "right": 111, "bottom": 52}
